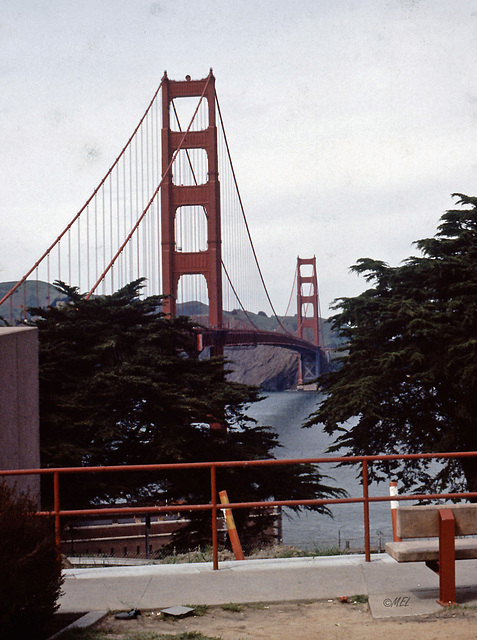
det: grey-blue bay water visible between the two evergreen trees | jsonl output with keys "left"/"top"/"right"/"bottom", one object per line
{"left": 248, "top": 391, "right": 392, "bottom": 549}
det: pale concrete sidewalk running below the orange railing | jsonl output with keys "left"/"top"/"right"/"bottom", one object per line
{"left": 60, "top": 554, "right": 477, "bottom": 618}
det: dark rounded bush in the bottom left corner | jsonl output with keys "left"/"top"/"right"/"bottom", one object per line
{"left": 0, "top": 483, "right": 62, "bottom": 640}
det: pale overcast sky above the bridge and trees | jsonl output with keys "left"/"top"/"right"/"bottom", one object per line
{"left": 0, "top": 0, "right": 477, "bottom": 316}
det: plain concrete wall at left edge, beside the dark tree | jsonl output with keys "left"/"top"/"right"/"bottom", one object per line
{"left": 0, "top": 327, "right": 40, "bottom": 499}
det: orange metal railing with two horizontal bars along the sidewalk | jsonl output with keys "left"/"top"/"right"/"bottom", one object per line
{"left": 0, "top": 451, "right": 477, "bottom": 569}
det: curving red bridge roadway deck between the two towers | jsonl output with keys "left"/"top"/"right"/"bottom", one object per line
{"left": 199, "top": 329, "right": 320, "bottom": 356}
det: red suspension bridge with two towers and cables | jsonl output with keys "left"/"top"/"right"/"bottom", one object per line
{"left": 0, "top": 70, "right": 323, "bottom": 384}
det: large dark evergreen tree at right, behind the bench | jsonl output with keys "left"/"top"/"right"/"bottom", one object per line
{"left": 307, "top": 194, "right": 477, "bottom": 491}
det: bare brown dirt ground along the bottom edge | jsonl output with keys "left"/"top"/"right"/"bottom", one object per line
{"left": 95, "top": 600, "right": 477, "bottom": 640}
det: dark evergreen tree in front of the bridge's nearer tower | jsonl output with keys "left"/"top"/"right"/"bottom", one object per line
{"left": 34, "top": 280, "right": 340, "bottom": 550}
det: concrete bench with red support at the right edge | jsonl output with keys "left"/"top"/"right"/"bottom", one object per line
{"left": 386, "top": 504, "right": 477, "bottom": 605}
